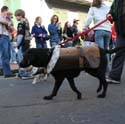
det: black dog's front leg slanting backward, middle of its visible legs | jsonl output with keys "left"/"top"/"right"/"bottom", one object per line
{"left": 67, "top": 77, "right": 82, "bottom": 99}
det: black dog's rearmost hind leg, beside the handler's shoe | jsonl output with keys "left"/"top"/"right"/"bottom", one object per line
{"left": 98, "top": 78, "right": 108, "bottom": 98}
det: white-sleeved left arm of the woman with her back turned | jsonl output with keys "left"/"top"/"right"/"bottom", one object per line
{"left": 83, "top": 7, "right": 94, "bottom": 29}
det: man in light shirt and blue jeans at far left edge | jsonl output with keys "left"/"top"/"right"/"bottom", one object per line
{"left": 0, "top": 6, "right": 16, "bottom": 78}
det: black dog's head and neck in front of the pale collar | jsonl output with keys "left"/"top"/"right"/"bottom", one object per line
{"left": 20, "top": 48, "right": 53, "bottom": 68}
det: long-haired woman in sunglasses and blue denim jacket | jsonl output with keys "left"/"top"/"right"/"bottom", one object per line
{"left": 48, "top": 15, "right": 61, "bottom": 47}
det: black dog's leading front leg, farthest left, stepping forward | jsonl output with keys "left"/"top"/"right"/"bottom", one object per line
{"left": 43, "top": 77, "right": 64, "bottom": 100}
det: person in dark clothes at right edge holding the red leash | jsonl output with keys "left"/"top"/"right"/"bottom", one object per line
{"left": 107, "top": 0, "right": 125, "bottom": 84}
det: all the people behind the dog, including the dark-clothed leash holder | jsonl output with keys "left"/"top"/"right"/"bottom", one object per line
{"left": 0, "top": 0, "right": 125, "bottom": 83}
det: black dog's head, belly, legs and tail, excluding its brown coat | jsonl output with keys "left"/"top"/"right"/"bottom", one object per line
{"left": 20, "top": 47, "right": 124, "bottom": 100}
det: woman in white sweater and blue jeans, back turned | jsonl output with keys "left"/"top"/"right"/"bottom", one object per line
{"left": 83, "top": 0, "right": 111, "bottom": 78}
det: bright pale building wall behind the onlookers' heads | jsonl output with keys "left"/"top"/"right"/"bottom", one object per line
{"left": 0, "top": 0, "right": 87, "bottom": 30}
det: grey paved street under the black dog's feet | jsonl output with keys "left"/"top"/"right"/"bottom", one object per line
{"left": 0, "top": 68, "right": 125, "bottom": 124}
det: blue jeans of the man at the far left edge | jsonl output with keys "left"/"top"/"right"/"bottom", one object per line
{"left": 0, "top": 35, "right": 12, "bottom": 76}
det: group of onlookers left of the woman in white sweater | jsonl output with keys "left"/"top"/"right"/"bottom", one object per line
{"left": 0, "top": 6, "right": 79, "bottom": 79}
